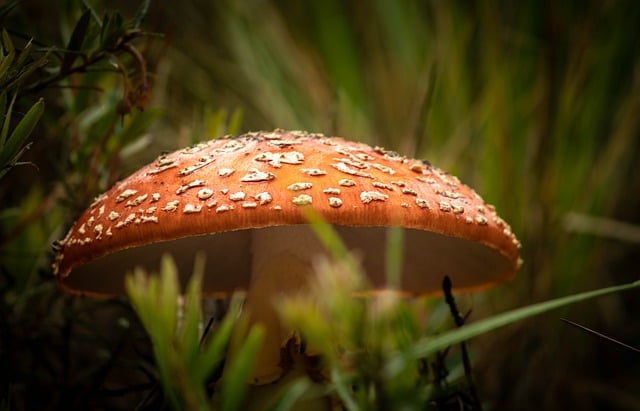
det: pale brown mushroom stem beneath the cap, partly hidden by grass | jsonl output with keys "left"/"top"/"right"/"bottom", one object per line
{"left": 231, "top": 225, "right": 324, "bottom": 384}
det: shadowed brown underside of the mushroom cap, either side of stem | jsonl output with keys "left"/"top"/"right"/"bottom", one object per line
{"left": 62, "top": 225, "right": 515, "bottom": 295}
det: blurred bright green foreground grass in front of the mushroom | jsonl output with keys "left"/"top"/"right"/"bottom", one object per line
{"left": 122, "top": 245, "right": 640, "bottom": 410}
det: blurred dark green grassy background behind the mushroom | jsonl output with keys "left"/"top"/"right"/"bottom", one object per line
{"left": 0, "top": 0, "right": 640, "bottom": 410}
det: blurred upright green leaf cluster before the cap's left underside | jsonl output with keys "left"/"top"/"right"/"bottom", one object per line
{"left": 126, "top": 256, "right": 270, "bottom": 410}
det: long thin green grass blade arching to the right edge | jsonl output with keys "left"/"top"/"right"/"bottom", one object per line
{"left": 387, "top": 281, "right": 640, "bottom": 374}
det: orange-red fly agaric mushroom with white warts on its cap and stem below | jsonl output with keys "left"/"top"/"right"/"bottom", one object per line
{"left": 54, "top": 130, "right": 519, "bottom": 383}
